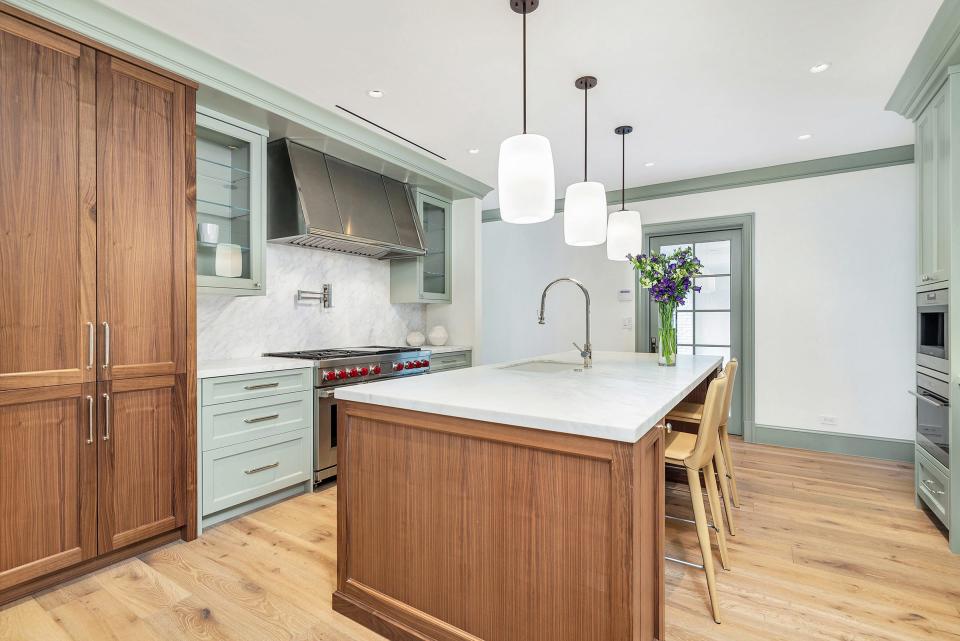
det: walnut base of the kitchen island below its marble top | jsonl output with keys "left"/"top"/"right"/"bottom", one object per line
{"left": 333, "top": 402, "right": 664, "bottom": 641}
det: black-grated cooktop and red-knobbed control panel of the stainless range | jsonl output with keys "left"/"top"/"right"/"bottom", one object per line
{"left": 264, "top": 345, "right": 430, "bottom": 388}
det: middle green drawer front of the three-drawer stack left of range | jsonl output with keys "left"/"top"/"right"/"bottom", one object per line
{"left": 200, "top": 391, "right": 313, "bottom": 452}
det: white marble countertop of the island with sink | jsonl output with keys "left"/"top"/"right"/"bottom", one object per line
{"left": 336, "top": 351, "right": 721, "bottom": 443}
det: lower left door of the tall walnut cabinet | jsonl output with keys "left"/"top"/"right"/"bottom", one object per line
{"left": 0, "top": 383, "right": 97, "bottom": 594}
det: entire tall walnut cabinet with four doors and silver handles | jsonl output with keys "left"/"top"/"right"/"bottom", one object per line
{"left": 0, "top": 5, "right": 196, "bottom": 603}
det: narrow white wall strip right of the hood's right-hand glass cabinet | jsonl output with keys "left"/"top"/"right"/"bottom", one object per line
{"left": 424, "top": 198, "right": 483, "bottom": 351}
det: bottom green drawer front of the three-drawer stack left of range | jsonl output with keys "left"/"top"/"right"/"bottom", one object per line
{"left": 203, "top": 430, "right": 313, "bottom": 516}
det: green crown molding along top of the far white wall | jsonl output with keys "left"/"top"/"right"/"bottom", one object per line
{"left": 483, "top": 145, "right": 913, "bottom": 223}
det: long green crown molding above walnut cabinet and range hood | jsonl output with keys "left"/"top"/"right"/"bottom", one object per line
{"left": 5, "top": 0, "right": 492, "bottom": 198}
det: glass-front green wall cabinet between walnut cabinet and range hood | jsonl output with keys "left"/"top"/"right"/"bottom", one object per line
{"left": 195, "top": 107, "right": 267, "bottom": 296}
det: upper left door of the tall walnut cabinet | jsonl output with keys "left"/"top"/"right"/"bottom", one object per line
{"left": 0, "top": 13, "right": 96, "bottom": 390}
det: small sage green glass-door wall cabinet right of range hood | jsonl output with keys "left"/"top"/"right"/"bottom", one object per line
{"left": 390, "top": 190, "right": 453, "bottom": 303}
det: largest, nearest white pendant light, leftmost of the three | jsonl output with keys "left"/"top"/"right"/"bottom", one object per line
{"left": 497, "top": 0, "right": 556, "bottom": 224}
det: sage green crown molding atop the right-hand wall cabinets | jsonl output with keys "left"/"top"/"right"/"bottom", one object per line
{"left": 886, "top": 0, "right": 960, "bottom": 120}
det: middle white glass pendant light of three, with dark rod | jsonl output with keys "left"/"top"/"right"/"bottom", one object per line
{"left": 563, "top": 76, "right": 607, "bottom": 247}
